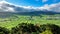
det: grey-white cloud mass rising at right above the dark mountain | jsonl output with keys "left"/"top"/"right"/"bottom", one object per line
{"left": 39, "top": 2, "right": 60, "bottom": 12}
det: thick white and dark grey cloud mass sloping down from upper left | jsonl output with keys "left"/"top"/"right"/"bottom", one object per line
{"left": 0, "top": 1, "right": 34, "bottom": 12}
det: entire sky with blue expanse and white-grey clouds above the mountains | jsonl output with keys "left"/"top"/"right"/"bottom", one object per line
{"left": 0, "top": 0, "right": 60, "bottom": 12}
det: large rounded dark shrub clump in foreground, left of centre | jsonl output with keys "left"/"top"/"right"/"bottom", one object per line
{"left": 12, "top": 23, "right": 40, "bottom": 33}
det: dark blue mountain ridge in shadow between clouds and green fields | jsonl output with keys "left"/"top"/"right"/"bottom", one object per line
{"left": 17, "top": 11, "right": 60, "bottom": 16}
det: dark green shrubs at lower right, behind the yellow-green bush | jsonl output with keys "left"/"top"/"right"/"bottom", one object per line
{"left": 41, "top": 24, "right": 60, "bottom": 34}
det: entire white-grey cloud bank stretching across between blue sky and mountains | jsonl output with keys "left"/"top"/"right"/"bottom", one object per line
{"left": 0, "top": 1, "right": 60, "bottom": 12}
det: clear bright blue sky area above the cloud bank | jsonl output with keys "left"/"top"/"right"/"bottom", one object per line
{"left": 1, "top": 0, "right": 60, "bottom": 7}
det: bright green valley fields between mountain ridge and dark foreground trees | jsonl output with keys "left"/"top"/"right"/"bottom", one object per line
{"left": 0, "top": 14, "right": 60, "bottom": 29}
